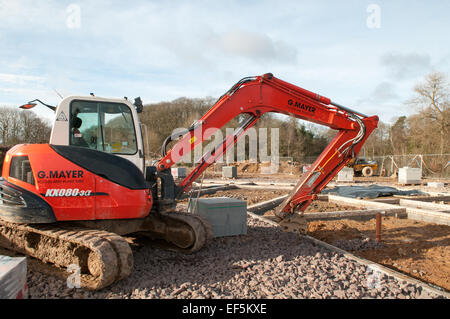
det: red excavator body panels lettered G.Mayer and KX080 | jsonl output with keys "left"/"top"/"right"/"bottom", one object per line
{"left": 2, "top": 144, "right": 153, "bottom": 222}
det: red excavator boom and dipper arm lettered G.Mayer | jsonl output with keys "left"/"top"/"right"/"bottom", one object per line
{"left": 156, "top": 73, "right": 378, "bottom": 219}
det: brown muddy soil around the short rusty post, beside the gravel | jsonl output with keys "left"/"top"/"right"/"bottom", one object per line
{"left": 308, "top": 217, "right": 450, "bottom": 290}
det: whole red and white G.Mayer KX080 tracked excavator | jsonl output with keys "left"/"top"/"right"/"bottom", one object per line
{"left": 0, "top": 73, "right": 378, "bottom": 290}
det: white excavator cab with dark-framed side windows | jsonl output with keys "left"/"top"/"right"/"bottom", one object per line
{"left": 50, "top": 96, "right": 145, "bottom": 172}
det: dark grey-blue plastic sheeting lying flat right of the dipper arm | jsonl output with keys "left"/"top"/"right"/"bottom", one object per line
{"left": 322, "top": 185, "right": 426, "bottom": 198}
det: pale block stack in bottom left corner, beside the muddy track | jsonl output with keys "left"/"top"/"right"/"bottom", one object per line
{"left": 0, "top": 255, "right": 28, "bottom": 299}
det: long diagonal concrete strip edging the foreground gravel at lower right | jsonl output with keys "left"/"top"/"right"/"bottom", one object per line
{"left": 247, "top": 210, "right": 450, "bottom": 299}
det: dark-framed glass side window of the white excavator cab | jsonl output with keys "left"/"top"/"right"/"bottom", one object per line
{"left": 70, "top": 100, "right": 137, "bottom": 155}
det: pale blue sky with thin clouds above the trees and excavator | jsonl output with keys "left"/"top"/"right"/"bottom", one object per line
{"left": 0, "top": 0, "right": 450, "bottom": 122}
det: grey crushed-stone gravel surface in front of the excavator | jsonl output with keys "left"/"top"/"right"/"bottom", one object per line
{"left": 28, "top": 216, "right": 442, "bottom": 299}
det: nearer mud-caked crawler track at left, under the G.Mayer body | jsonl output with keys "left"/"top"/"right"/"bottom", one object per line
{"left": 0, "top": 220, "right": 133, "bottom": 290}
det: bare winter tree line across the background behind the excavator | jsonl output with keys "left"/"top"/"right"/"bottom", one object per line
{"left": 0, "top": 72, "right": 450, "bottom": 161}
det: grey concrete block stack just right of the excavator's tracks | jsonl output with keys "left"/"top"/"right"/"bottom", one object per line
{"left": 188, "top": 197, "right": 247, "bottom": 237}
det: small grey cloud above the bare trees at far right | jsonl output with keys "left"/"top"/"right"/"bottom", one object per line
{"left": 380, "top": 52, "right": 431, "bottom": 80}
